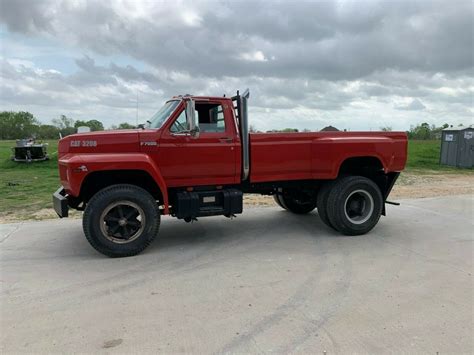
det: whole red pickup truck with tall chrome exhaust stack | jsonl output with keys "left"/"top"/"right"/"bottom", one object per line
{"left": 53, "top": 90, "right": 407, "bottom": 257}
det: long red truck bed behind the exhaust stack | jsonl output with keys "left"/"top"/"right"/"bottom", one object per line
{"left": 250, "top": 132, "right": 407, "bottom": 182}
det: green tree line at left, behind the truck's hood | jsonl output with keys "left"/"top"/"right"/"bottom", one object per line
{"left": 0, "top": 111, "right": 135, "bottom": 139}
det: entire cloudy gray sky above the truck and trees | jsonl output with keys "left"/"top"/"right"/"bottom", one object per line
{"left": 0, "top": 0, "right": 474, "bottom": 130}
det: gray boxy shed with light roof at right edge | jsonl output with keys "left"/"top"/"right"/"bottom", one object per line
{"left": 439, "top": 125, "right": 474, "bottom": 168}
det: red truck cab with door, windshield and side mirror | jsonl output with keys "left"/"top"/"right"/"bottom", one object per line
{"left": 144, "top": 97, "right": 241, "bottom": 187}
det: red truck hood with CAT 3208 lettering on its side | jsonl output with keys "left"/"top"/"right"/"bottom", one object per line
{"left": 58, "top": 129, "right": 140, "bottom": 156}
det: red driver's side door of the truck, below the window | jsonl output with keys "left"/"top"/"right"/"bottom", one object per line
{"left": 157, "top": 101, "right": 240, "bottom": 187}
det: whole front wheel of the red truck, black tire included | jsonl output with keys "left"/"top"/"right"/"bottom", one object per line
{"left": 82, "top": 184, "right": 160, "bottom": 257}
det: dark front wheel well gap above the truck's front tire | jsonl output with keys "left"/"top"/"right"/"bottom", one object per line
{"left": 80, "top": 170, "right": 163, "bottom": 202}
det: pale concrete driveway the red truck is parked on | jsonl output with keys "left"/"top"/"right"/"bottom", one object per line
{"left": 0, "top": 195, "right": 474, "bottom": 354}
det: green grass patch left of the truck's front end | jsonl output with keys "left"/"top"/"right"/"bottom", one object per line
{"left": 0, "top": 141, "right": 60, "bottom": 219}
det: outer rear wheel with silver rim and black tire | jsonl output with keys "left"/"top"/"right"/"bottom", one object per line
{"left": 327, "top": 176, "right": 383, "bottom": 235}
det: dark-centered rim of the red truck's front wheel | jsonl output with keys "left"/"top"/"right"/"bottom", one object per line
{"left": 100, "top": 201, "right": 145, "bottom": 244}
